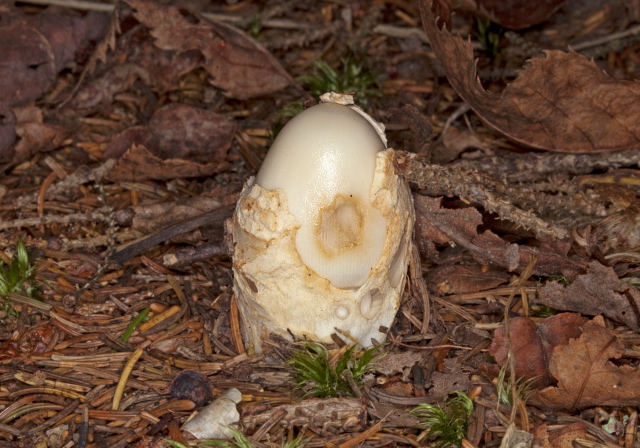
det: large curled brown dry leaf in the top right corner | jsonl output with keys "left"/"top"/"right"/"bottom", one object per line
{"left": 420, "top": 0, "right": 640, "bottom": 153}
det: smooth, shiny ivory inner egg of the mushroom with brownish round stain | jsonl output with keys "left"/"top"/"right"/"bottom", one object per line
{"left": 256, "top": 103, "right": 387, "bottom": 288}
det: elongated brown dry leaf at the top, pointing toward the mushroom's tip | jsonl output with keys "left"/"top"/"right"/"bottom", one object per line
{"left": 127, "top": 0, "right": 296, "bottom": 99}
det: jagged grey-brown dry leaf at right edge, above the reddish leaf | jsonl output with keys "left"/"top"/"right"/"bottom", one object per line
{"left": 532, "top": 261, "right": 640, "bottom": 331}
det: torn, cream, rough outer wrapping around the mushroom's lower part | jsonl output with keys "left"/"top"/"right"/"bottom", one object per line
{"left": 230, "top": 149, "right": 414, "bottom": 353}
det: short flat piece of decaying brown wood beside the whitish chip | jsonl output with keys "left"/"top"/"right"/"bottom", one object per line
{"left": 241, "top": 398, "right": 367, "bottom": 434}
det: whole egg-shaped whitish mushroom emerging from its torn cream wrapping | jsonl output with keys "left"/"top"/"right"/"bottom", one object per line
{"left": 229, "top": 93, "right": 415, "bottom": 353}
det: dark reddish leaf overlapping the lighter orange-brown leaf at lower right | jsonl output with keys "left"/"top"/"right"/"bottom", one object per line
{"left": 489, "top": 313, "right": 587, "bottom": 386}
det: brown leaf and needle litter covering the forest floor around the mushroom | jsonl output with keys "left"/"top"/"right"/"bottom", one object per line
{"left": 0, "top": 0, "right": 640, "bottom": 448}
